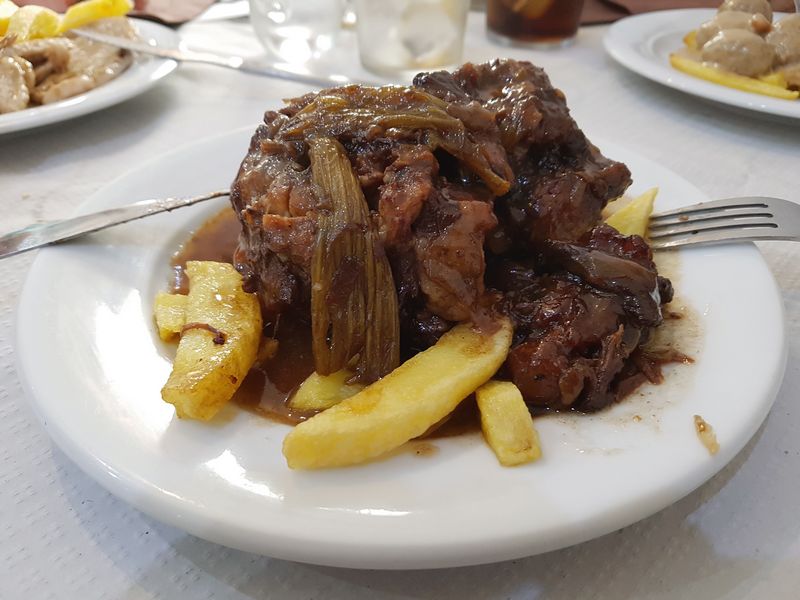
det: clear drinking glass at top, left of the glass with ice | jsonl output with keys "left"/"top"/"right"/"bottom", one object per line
{"left": 250, "top": 0, "right": 344, "bottom": 64}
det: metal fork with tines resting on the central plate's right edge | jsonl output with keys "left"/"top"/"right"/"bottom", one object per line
{"left": 648, "top": 196, "right": 800, "bottom": 250}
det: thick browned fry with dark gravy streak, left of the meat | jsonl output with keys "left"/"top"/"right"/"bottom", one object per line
{"left": 161, "top": 261, "right": 262, "bottom": 421}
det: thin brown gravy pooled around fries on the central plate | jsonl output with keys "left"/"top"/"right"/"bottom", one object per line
{"left": 170, "top": 208, "right": 694, "bottom": 439}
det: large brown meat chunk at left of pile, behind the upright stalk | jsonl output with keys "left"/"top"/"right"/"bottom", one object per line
{"left": 231, "top": 81, "right": 513, "bottom": 320}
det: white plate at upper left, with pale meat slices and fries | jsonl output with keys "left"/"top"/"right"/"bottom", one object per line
{"left": 0, "top": 19, "right": 180, "bottom": 134}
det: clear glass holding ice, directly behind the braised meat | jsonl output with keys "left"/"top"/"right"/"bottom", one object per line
{"left": 356, "top": 0, "right": 469, "bottom": 77}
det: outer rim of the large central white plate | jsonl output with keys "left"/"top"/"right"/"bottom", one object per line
{"left": 12, "top": 127, "right": 788, "bottom": 569}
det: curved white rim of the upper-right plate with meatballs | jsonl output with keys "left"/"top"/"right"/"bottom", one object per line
{"left": 603, "top": 8, "right": 800, "bottom": 119}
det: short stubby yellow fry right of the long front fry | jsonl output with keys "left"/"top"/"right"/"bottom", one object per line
{"left": 475, "top": 381, "right": 542, "bottom": 467}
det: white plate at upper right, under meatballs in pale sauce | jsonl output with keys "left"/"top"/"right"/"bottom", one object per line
{"left": 603, "top": 8, "right": 800, "bottom": 119}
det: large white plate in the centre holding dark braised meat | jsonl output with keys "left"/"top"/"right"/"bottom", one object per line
{"left": 16, "top": 125, "right": 786, "bottom": 569}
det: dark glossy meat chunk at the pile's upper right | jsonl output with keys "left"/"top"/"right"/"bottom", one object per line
{"left": 414, "top": 60, "right": 630, "bottom": 249}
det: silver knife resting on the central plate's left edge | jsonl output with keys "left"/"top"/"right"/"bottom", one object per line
{"left": 0, "top": 190, "right": 229, "bottom": 259}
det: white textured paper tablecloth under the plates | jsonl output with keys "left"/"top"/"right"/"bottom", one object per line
{"left": 0, "top": 14, "right": 800, "bottom": 600}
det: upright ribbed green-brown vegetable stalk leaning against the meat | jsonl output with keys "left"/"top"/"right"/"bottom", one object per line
{"left": 308, "top": 137, "right": 400, "bottom": 382}
